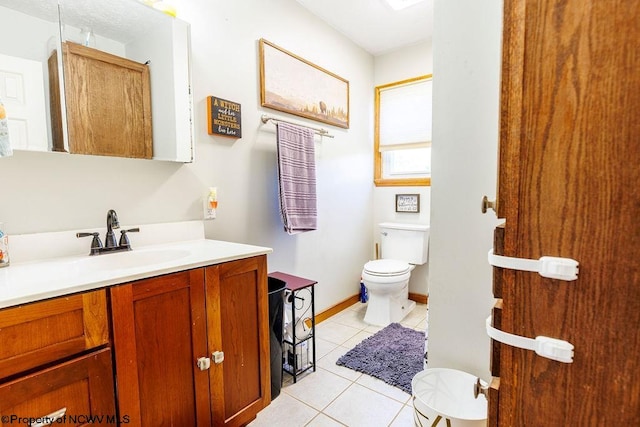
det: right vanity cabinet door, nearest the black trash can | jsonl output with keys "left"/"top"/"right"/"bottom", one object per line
{"left": 205, "top": 256, "right": 271, "bottom": 426}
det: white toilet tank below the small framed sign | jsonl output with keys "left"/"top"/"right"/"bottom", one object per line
{"left": 379, "top": 222, "right": 429, "bottom": 265}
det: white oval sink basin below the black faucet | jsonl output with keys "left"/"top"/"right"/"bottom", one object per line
{"left": 76, "top": 249, "right": 191, "bottom": 270}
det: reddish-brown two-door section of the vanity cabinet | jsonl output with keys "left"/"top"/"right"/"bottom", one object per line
{"left": 110, "top": 256, "right": 271, "bottom": 426}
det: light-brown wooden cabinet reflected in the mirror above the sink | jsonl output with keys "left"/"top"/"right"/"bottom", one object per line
{"left": 49, "top": 42, "right": 153, "bottom": 159}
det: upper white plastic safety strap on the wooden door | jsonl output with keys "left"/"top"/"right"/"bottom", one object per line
{"left": 488, "top": 249, "right": 578, "bottom": 281}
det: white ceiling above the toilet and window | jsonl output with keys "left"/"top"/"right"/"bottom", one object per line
{"left": 296, "top": 0, "right": 433, "bottom": 56}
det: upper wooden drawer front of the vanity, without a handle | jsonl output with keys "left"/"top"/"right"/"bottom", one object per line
{"left": 0, "top": 289, "right": 109, "bottom": 380}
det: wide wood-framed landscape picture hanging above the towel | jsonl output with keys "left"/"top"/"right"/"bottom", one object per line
{"left": 260, "top": 39, "right": 349, "bottom": 129}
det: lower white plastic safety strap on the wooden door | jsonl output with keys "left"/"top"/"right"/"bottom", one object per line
{"left": 487, "top": 316, "right": 573, "bottom": 363}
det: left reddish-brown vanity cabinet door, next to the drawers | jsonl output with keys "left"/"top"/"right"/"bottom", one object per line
{"left": 111, "top": 269, "right": 211, "bottom": 427}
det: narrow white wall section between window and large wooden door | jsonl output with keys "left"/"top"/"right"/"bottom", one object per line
{"left": 428, "top": 0, "right": 502, "bottom": 379}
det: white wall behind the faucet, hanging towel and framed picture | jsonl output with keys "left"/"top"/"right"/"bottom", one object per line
{"left": 0, "top": 0, "right": 373, "bottom": 311}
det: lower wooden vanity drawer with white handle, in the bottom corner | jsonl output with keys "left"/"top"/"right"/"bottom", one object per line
{"left": 0, "top": 348, "right": 115, "bottom": 427}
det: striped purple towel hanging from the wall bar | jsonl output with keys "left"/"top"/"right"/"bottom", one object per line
{"left": 277, "top": 123, "right": 318, "bottom": 234}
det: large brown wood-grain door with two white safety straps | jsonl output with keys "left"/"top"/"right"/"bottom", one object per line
{"left": 489, "top": 0, "right": 640, "bottom": 426}
